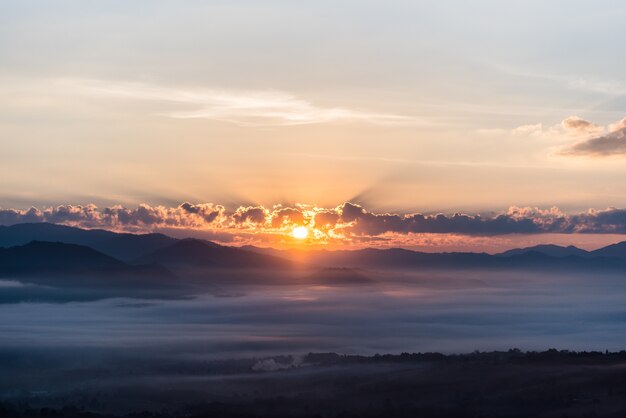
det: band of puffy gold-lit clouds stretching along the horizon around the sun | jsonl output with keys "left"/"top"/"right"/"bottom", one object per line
{"left": 0, "top": 202, "right": 626, "bottom": 241}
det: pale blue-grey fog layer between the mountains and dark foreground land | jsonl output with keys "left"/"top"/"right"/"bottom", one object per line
{"left": 0, "top": 272, "right": 626, "bottom": 359}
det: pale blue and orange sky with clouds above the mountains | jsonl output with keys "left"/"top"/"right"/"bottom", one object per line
{"left": 0, "top": 0, "right": 626, "bottom": 250}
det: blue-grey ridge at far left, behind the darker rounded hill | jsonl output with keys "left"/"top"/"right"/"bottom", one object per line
{"left": 0, "top": 223, "right": 177, "bottom": 261}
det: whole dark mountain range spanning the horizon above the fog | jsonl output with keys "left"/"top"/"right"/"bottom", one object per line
{"left": 0, "top": 223, "right": 626, "bottom": 277}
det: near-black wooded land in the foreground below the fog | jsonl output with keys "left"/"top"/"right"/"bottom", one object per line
{"left": 0, "top": 349, "right": 626, "bottom": 418}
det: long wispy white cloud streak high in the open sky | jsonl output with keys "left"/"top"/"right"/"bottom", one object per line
{"left": 57, "top": 79, "right": 420, "bottom": 126}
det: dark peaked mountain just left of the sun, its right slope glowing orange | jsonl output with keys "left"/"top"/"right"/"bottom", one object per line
{"left": 136, "top": 239, "right": 291, "bottom": 269}
